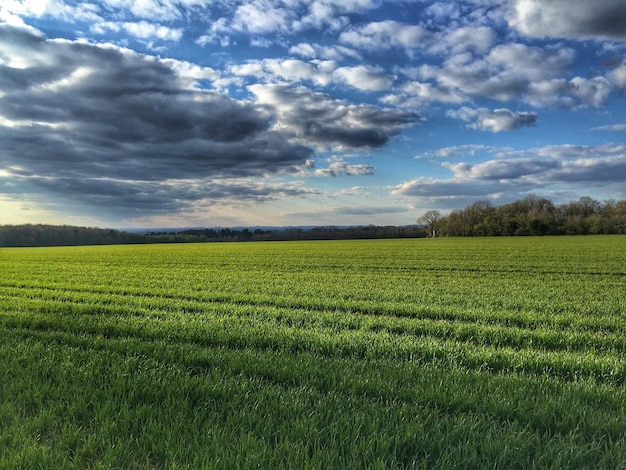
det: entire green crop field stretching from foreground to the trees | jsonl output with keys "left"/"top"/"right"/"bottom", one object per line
{"left": 0, "top": 236, "right": 626, "bottom": 469}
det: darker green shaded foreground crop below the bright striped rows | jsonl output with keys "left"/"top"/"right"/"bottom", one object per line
{"left": 0, "top": 330, "right": 624, "bottom": 468}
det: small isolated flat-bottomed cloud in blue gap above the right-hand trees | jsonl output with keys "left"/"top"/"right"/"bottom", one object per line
{"left": 447, "top": 106, "right": 537, "bottom": 132}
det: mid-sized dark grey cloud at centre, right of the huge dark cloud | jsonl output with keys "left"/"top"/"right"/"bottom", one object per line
{"left": 249, "top": 84, "right": 420, "bottom": 150}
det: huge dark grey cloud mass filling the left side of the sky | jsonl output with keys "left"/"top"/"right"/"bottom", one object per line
{"left": 0, "top": 25, "right": 312, "bottom": 217}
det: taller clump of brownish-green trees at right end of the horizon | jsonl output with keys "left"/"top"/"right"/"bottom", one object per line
{"left": 418, "top": 195, "right": 626, "bottom": 237}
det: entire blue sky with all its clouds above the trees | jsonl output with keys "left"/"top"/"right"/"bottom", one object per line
{"left": 0, "top": 0, "right": 626, "bottom": 228}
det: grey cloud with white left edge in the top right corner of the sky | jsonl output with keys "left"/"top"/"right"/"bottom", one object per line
{"left": 508, "top": 0, "right": 626, "bottom": 40}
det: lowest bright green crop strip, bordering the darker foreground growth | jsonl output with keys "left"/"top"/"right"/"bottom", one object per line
{"left": 0, "top": 313, "right": 626, "bottom": 383}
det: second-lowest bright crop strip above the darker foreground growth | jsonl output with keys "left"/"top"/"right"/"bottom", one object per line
{"left": 0, "top": 296, "right": 626, "bottom": 352}
